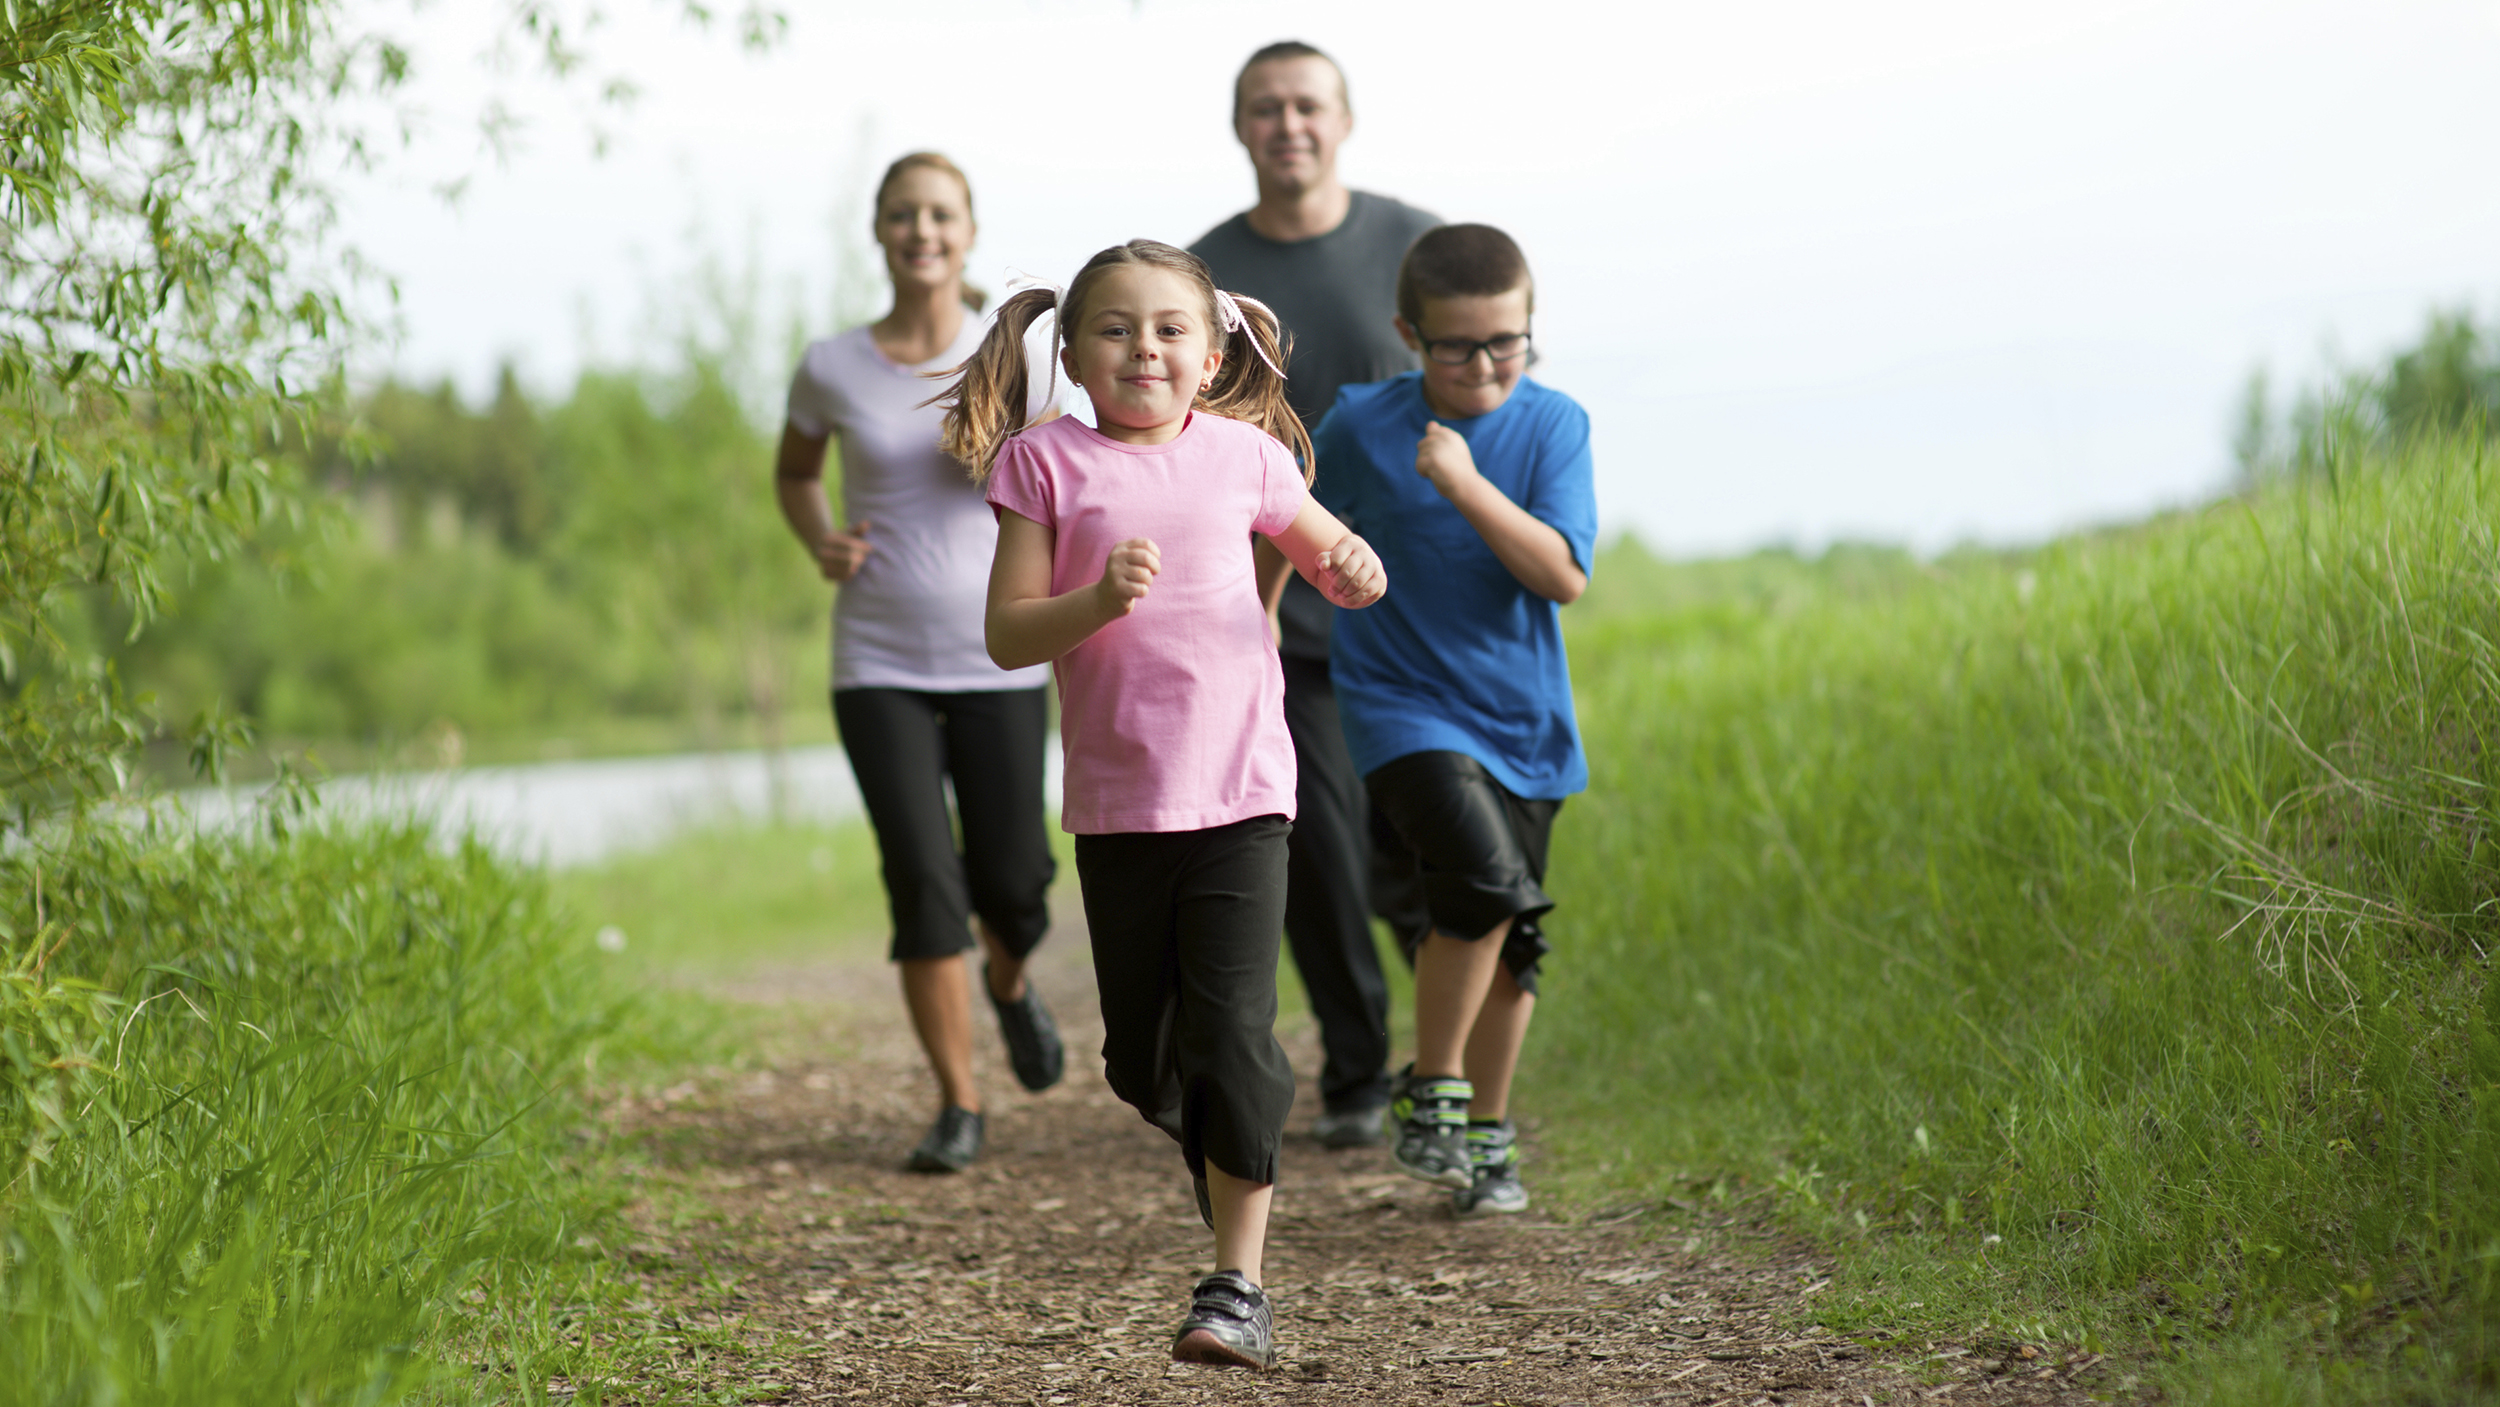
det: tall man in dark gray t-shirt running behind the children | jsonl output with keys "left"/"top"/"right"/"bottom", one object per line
{"left": 1190, "top": 40, "right": 1440, "bottom": 1147}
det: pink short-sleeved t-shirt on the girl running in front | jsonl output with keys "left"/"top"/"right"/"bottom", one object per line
{"left": 990, "top": 412, "right": 1308, "bottom": 835}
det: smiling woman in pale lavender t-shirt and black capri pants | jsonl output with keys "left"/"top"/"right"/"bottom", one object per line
{"left": 775, "top": 152, "right": 1063, "bottom": 1172}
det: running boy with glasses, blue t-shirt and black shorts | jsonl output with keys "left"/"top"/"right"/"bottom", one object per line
{"left": 1313, "top": 225, "right": 1598, "bottom": 1215}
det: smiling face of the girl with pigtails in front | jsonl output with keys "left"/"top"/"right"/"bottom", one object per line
{"left": 1060, "top": 265, "right": 1225, "bottom": 445}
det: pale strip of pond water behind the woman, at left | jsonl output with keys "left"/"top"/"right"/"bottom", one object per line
{"left": 173, "top": 745, "right": 1060, "bottom": 867}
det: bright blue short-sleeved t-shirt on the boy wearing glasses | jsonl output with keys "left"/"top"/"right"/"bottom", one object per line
{"left": 1310, "top": 372, "right": 1598, "bottom": 800}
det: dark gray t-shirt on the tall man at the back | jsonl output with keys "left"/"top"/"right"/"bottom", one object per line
{"left": 1190, "top": 190, "right": 1440, "bottom": 660}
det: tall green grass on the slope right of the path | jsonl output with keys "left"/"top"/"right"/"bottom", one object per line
{"left": 1530, "top": 437, "right": 2500, "bottom": 1400}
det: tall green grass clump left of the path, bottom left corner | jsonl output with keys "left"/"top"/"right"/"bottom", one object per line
{"left": 0, "top": 825, "right": 635, "bottom": 1407}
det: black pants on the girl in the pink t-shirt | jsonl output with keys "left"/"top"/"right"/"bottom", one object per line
{"left": 1078, "top": 815, "right": 1293, "bottom": 1182}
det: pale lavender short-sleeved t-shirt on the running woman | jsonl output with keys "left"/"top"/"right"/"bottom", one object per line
{"left": 790, "top": 315, "right": 1065, "bottom": 695}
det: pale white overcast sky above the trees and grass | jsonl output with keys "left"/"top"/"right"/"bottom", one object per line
{"left": 343, "top": 0, "right": 2500, "bottom": 555}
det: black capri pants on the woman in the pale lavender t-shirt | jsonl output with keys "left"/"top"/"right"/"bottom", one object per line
{"left": 833, "top": 690, "right": 1055, "bottom": 962}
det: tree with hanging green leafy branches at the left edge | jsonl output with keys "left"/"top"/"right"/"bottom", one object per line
{"left": 0, "top": 0, "right": 385, "bottom": 825}
